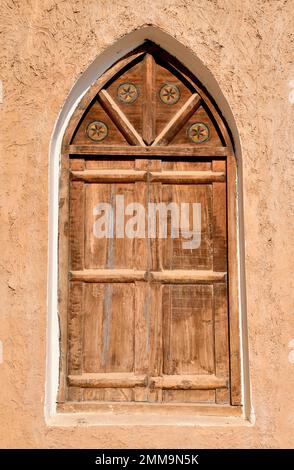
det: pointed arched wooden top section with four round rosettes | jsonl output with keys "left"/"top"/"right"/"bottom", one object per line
{"left": 65, "top": 43, "right": 230, "bottom": 151}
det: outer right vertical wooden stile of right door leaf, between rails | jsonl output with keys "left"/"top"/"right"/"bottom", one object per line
{"left": 212, "top": 160, "right": 230, "bottom": 403}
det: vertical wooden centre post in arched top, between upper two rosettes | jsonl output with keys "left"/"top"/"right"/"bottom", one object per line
{"left": 142, "top": 54, "right": 156, "bottom": 145}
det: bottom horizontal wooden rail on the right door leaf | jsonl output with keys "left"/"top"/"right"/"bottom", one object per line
{"left": 149, "top": 375, "right": 228, "bottom": 390}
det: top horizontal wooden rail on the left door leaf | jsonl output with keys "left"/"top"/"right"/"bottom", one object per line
{"left": 71, "top": 170, "right": 147, "bottom": 183}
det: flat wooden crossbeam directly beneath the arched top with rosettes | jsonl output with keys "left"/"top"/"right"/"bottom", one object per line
{"left": 65, "top": 144, "right": 231, "bottom": 158}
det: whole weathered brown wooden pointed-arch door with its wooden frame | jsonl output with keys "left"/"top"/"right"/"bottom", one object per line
{"left": 59, "top": 43, "right": 241, "bottom": 412}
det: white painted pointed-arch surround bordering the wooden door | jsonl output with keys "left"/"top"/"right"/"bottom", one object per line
{"left": 45, "top": 26, "right": 253, "bottom": 424}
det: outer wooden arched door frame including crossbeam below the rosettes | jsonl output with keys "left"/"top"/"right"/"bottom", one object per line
{"left": 58, "top": 44, "right": 242, "bottom": 414}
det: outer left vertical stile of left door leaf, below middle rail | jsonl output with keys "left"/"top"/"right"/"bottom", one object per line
{"left": 67, "top": 282, "right": 84, "bottom": 401}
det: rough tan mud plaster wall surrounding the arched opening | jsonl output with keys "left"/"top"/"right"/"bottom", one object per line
{"left": 0, "top": 0, "right": 294, "bottom": 448}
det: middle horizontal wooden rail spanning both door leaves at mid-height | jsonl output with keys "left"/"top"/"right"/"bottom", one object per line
{"left": 70, "top": 269, "right": 226, "bottom": 284}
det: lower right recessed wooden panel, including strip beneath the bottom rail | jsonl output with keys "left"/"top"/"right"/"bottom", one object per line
{"left": 163, "top": 285, "right": 215, "bottom": 402}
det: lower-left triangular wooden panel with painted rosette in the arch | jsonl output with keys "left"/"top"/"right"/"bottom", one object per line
{"left": 72, "top": 100, "right": 128, "bottom": 145}
